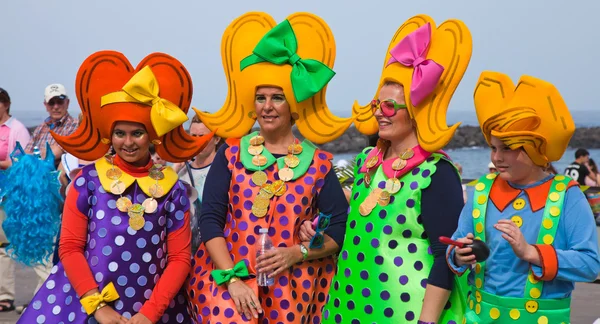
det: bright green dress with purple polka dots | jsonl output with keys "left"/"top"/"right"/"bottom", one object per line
{"left": 323, "top": 150, "right": 463, "bottom": 324}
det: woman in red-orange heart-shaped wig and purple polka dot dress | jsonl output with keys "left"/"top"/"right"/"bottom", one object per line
{"left": 19, "top": 51, "right": 210, "bottom": 324}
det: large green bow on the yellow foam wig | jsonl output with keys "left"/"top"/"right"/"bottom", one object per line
{"left": 240, "top": 19, "right": 335, "bottom": 102}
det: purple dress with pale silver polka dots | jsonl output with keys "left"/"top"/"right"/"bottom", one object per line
{"left": 19, "top": 165, "right": 191, "bottom": 324}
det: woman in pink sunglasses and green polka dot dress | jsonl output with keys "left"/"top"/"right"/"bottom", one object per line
{"left": 314, "top": 15, "right": 472, "bottom": 323}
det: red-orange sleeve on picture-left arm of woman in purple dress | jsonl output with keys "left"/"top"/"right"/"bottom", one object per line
{"left": 58, "top": 181, "right": 98, "bottom": 296}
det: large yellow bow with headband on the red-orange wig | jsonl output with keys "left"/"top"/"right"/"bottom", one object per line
{"left": 101, "top": 66, "right": 188, "bottom": 136}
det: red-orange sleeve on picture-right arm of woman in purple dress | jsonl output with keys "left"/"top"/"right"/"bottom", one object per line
{"left": 140, "top": 211, "right": 192, "bottom": 323}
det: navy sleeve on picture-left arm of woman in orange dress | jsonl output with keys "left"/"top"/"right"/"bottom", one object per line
{"left": 199, "top": 144, "right": 231, "bottom": 242}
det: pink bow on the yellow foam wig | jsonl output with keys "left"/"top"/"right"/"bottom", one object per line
{"left": 386, "top": 23, "right": 444, "bottom": 106}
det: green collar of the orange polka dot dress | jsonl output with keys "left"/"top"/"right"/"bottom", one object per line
{"left": 240, "top": 131, "right": 317, "bottom": 180}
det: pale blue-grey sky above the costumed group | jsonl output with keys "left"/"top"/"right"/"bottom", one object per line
{"left": 0, "top": 0, "right": 600, "bottom": 126}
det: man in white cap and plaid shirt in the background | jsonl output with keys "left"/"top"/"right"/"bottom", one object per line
{"left": 25, "top": 83, "right": 77, "bottom": 161}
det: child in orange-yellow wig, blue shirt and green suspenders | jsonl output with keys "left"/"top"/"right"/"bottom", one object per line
{"left": 448, "top": 72, "right": 600, "bottom": 324}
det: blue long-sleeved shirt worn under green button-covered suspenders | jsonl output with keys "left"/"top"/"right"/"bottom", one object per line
{"left": 448, "top": 176, "right": 600, "bottom": 298}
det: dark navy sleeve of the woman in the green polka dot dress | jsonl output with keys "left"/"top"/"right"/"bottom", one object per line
{"left": 421, "top": 160, "right": 464, "bottom": 290}
